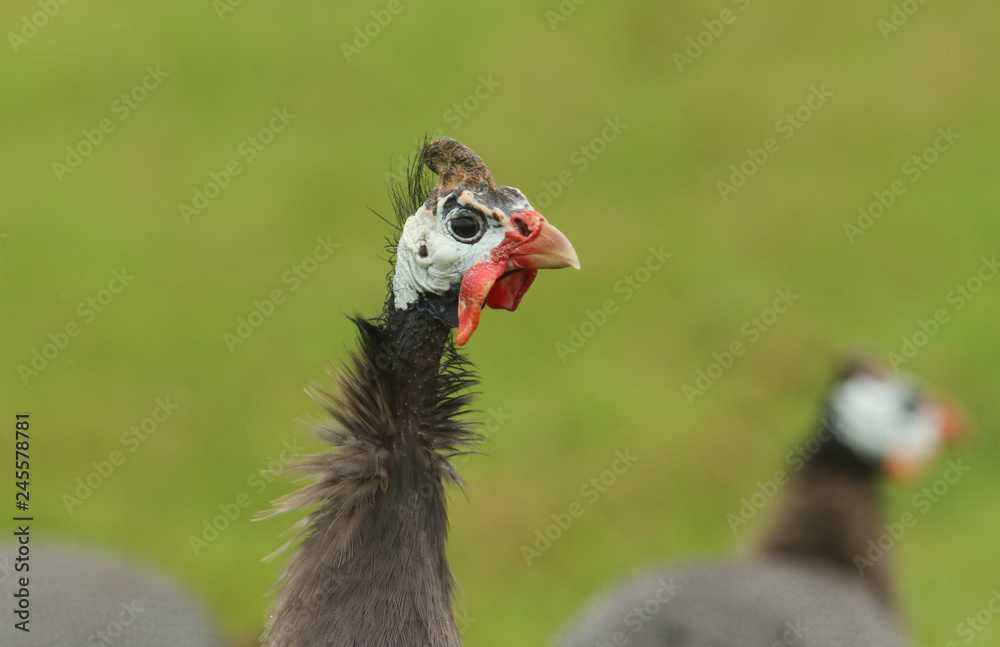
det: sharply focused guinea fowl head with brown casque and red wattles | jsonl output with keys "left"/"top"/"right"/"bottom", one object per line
{"left": 393, "top": 137, "right": 580, "bottom": 345}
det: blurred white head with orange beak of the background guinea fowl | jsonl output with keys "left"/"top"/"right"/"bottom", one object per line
{"left": 828, "top": 359, "right": 965, "bottom": 481}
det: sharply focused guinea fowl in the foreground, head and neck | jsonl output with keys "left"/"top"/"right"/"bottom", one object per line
{"left": 264, "top": 137, "right": 579, "bottom": 647}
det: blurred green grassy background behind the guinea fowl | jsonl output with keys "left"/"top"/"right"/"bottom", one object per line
{"left": 0, "top": 0, "right": 1000, "bottom": 646}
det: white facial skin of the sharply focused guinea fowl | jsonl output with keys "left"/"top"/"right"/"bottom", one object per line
{"left": 392, "top": 191, "right": 531, "bottom": 310}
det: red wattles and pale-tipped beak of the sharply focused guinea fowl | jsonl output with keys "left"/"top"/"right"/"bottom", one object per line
{"left": 455, "top": 211, "right": 580, "bottom": 346}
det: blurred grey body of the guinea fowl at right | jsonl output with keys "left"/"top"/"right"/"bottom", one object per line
{"left": 553, "top": 558, "right": 907, "bottom": 647}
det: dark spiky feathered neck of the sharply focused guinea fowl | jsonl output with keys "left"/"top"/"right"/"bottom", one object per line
{"left": 267, "top": 295, "right": 478, "bottom": 647}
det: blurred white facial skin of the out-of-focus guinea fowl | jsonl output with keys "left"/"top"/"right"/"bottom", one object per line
{"left": 830, "top": 375, "right": 942, "bottom": 462}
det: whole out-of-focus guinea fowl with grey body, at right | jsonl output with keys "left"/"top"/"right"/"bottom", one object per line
{"left": 554, "top": 361, "right": 961, "bottom": 647}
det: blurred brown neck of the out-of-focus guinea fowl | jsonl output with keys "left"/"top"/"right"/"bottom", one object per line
{"left": 759, "top": 412, "right": 892, "bottom": 606}
